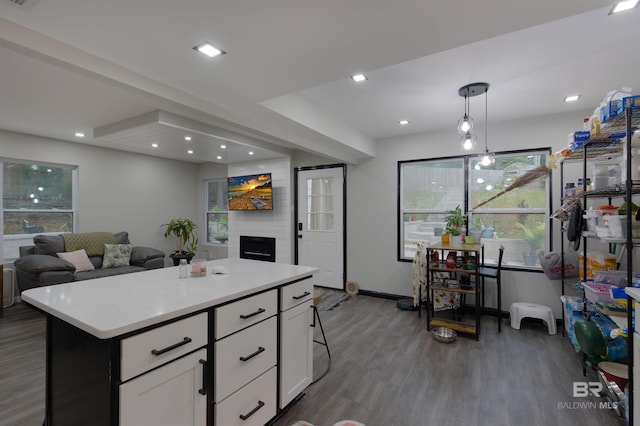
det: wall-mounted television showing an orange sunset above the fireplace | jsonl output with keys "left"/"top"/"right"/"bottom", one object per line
{"left": 227, "top": 173, "right": 273, "bottom": 210}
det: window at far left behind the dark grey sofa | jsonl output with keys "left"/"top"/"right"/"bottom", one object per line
{"left": 2, "top": 159, "right": 77, "bottom": 259}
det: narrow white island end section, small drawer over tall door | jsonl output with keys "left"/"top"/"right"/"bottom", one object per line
{"left": 279, "top": 278, "right": 313, "bottom": 408}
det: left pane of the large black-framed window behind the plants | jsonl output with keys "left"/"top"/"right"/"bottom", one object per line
{"left": 398, "top": 158, "right": 465, "bottom": 260}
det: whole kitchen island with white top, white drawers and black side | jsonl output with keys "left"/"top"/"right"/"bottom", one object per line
{"left": 22, "top": 259, "right": 316, "bottom": 426}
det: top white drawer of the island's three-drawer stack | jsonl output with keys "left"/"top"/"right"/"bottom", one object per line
{"left": 215, "top": 290, "right": 278, "bottom": 339}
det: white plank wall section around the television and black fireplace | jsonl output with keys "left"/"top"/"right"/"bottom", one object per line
{"left": 228, "top": 157, "right": 294, "bottom": 263}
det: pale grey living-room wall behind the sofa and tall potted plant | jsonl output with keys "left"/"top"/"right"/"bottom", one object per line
{"left": 0, "top": 130, "right": 201, "bottom": 262}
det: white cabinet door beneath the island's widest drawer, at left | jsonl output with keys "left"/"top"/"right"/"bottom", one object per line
{"left": 120, "top": 349, "right": 207, "bottom": 426}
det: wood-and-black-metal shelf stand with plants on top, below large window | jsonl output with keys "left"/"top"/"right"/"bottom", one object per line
{"left": 427, "top": 243, "right": 484, "bottom": 340}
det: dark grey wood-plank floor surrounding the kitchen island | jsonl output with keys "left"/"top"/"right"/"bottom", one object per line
{"left": 0, "top": 296, "right": 625, "bottom": 426}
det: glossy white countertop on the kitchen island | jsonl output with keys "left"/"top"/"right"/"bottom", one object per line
{"left": 21, "top": 259, "right": 317, "bottom": 339}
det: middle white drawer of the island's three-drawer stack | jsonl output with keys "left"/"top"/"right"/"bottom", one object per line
{"left": 214, "top": 317, "right": 277, "bottom": 402}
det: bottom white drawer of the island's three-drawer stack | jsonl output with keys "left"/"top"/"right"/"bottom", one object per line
{"left": 214, "top": 367, "right": 277, "bottom": 426}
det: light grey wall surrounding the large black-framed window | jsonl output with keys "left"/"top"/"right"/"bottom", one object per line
{"left": 347, "top": 112, "right": 588, "bottom": 315}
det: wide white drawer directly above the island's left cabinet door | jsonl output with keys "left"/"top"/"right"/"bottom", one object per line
{"left": 120, "top": 313, "right": 208, "bottom": 381}
